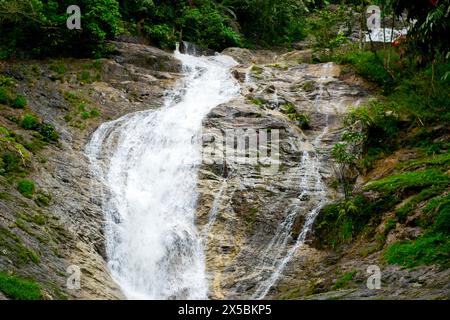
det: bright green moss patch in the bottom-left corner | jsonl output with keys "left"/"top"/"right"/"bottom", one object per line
{"left": 0, "top": 272, "right": 43, "bottom": 300}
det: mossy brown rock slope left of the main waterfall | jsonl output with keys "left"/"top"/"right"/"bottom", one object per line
{"left": 0, "top": 43, "right": 181, "bottom": 299}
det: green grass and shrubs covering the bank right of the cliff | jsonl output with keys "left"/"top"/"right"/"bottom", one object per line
{"left": 315, "top": 1, "right": 450, "bottom": 268}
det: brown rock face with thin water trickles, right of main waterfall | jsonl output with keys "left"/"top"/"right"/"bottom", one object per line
{"left": 198, "top": 49, "right": 368, "bottom": 299}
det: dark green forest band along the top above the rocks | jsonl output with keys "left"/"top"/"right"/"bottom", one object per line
{"left": 0, "top": 0, "right": 450, "bottom": 56}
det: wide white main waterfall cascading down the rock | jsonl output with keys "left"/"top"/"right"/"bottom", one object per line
{"left": 86, "top": 46, "right": 239, "bottom": 299}
